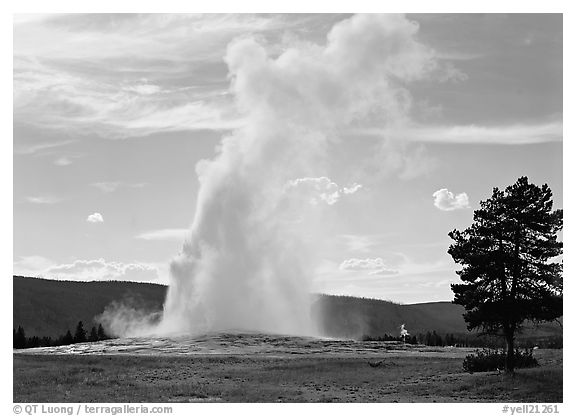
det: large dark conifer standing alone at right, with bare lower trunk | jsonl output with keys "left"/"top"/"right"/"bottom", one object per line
{"left": 448, "top": 176, "right": 563, "bottom": 372}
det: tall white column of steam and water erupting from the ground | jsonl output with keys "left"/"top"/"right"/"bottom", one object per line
{"left": 143, "top": 15, "right": 435, "bottom": 335}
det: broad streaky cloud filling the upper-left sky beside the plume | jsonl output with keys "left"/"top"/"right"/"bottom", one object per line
{"left": 14, "top": 14, "right": 335, "bottom": 138}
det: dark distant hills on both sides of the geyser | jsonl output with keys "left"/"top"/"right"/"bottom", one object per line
{"left": 13, "top": 276, "right": 562, "bottom": 338}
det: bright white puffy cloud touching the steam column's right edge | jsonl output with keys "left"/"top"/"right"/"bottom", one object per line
{"left": 286, "top": 176, "right": 362, "bottom": 205}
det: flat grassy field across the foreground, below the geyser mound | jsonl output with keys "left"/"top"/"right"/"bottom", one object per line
{"left": 14, "top": 348, "right": 562, "bottom": 403}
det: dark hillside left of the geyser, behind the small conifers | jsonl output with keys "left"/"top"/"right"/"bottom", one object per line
{"left": 12, "top": 276, "right": 166, "bottom": 337}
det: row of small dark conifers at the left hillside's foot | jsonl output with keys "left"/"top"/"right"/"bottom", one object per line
{"left": 12, "top": 321, "right": 110, "bottom": 349}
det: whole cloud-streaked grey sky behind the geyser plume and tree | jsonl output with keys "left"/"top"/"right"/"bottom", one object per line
{"left": 13, "top": 14, "right": 563, "bottom": 303}
